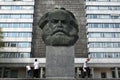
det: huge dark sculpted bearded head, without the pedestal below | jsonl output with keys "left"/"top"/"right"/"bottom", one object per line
{"left": 39, "top": 8, "right": 78, "bottom": 46}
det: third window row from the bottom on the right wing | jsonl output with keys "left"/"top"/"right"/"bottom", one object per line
{"left": 87, "top": 32, "right": 120, "bottom": 38}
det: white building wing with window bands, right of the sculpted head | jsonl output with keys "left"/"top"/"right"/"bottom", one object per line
{"left": 86, "top": 0, "right": 120, "bottom": 78}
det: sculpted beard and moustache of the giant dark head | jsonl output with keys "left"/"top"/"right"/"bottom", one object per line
{"left": 42, "top": 24, "right": 78, "bottom": 46}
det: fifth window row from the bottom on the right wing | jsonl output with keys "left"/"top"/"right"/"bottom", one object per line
{"left": 87, "top": 14, "right": 120, "bottom": 19}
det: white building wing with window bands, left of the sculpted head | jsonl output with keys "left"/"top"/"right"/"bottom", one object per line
{"left": 0, "top": 0, "right": 34, "bottom": 77}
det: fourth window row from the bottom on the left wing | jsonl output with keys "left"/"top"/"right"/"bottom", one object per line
{"left": 0, "top": 23, "right": 32, "bottom": 28}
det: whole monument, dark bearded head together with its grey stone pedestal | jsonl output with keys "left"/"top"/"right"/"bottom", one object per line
{"left": 39, "top": 8, "right": 78, "bottom": 78}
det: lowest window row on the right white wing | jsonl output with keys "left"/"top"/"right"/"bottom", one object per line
{"left": 89, "top": 52, "right": 120, "bottom": 58}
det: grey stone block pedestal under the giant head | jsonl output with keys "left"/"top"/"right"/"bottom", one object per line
{"left": 46, "top": 46, "right": 75, "bottom": 78}
